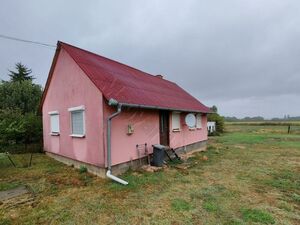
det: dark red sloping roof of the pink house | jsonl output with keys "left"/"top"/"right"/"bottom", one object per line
{"left": 49, "top": 42, "right": 210, "bottom": 113}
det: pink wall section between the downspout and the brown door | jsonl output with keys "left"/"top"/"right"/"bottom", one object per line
{"left": 104, "top": 104, "right": 159, "bottom": 165}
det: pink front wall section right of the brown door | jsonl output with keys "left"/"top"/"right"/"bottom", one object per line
{"left": 170, "top": 113, "right": 207, "bottom": 148}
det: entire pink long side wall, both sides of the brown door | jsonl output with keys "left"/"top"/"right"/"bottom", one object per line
{"left": 103, "top": 103, "right": 207, "bottom": 165}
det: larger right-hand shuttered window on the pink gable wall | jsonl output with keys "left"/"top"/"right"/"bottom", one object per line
{"left": 68, "top": 106, "right": 85, "bottom": 137}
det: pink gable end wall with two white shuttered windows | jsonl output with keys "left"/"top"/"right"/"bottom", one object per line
{"left": 43, "top": 49, "right": 104, "bottom": 166}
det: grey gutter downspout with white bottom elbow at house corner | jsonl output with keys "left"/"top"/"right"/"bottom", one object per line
{"left": 106, "top": 99, "right": 128, "bottom": 185}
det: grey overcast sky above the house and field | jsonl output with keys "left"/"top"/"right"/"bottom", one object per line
{"left": 0, "top": 0, "right": 300, "bottom": 118}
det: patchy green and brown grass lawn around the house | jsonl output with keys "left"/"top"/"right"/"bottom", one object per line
{"left": 0, "top": 125, "right": 300, "bottom": 225}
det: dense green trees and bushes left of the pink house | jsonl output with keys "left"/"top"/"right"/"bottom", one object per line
{"left": 0, "top": 63, "right": 42, "bottom": 152}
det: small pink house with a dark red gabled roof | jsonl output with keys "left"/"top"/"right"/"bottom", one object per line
{"left": 41, "top": 42, "right": 210, "bottom": 184}
